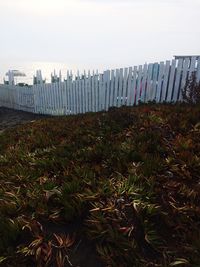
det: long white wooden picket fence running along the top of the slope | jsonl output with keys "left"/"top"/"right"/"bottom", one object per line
{"left": 0, "top": 56, "right": 200, "bottom": 115}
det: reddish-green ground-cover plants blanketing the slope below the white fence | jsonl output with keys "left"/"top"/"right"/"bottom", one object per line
{"left": 0, "top": 105, "right": 200, "bottom": 267}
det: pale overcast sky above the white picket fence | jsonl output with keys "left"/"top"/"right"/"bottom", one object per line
{"left": 0, "top": 0, "right": 200, "bottom": 81}
